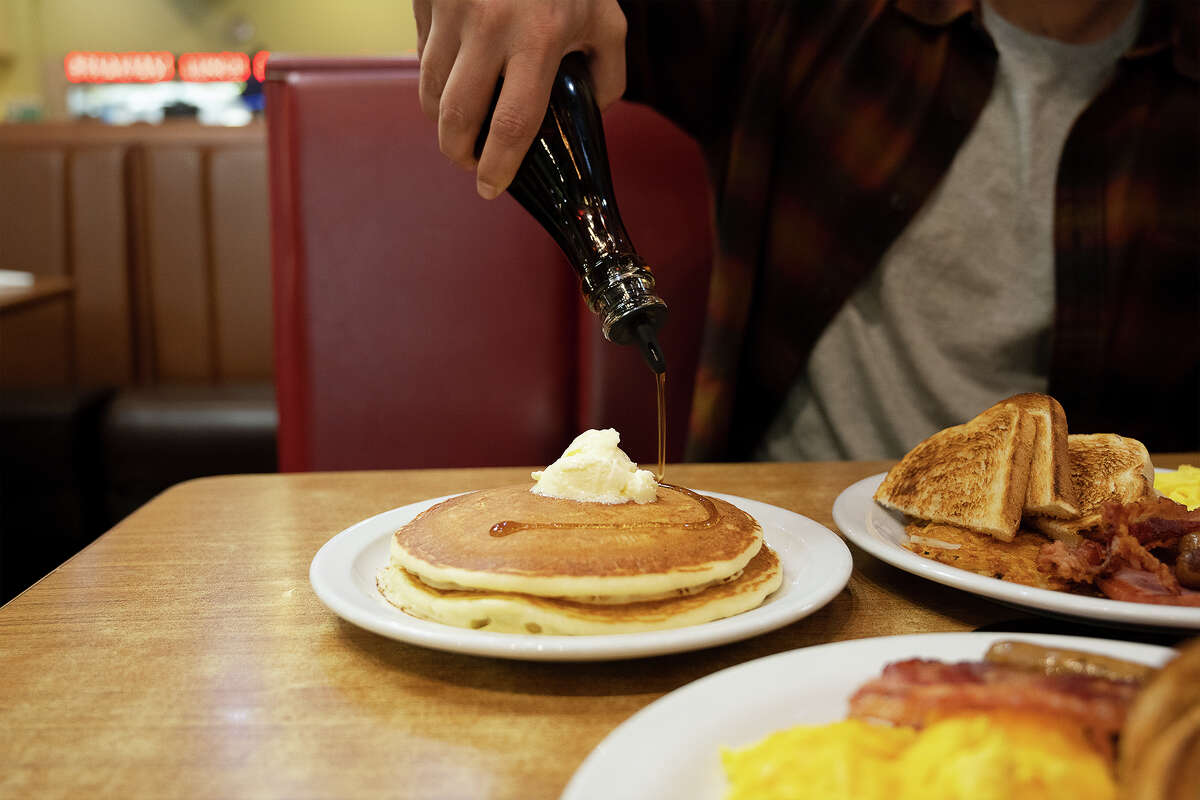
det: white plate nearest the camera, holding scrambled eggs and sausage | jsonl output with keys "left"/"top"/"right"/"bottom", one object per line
{"left": 560, "top": 633, "right": 1172, "bottom": 800}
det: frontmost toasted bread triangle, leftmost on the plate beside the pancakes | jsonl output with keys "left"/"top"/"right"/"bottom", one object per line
{"left": 875, "top": 402, "right": 1037, "bottom": 542}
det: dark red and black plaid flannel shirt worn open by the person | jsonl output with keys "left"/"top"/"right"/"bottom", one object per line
{"left": 623, "top": 0, "right": 1200, "bottom": 461}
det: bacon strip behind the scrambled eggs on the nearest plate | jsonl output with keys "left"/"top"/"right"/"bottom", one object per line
{"left": 850, "top": 658, "right": 1138, "bottom": 756}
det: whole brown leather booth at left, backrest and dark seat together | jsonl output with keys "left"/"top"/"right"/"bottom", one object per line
{"left": 0, "top": 122, "right": 276, "bottom": 596}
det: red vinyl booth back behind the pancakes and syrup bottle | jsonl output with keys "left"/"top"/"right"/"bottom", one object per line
{"left": 266, "top": 58, "right": 712, "bottom": 471}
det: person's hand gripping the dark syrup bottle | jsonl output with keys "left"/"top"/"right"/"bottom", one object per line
{"left": 413, "top": 0, "right": 625, "bottom": 199}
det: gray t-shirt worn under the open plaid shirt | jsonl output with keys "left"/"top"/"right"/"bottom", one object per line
{"left": 758, "top": 2, "right": 1141, "bottom": 461}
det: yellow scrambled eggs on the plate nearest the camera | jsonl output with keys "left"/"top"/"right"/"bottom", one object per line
{"left": 721, "top": 712, "right": 1116, "bottom": 800}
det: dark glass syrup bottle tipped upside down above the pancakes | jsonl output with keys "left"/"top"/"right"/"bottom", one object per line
{"left": 475, "top": 53, "right": 667, "bottom": 374}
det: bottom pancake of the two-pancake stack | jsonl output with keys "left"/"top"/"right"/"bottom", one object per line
{"left": 377, "top": 546, "right": 782, "bottom": 634}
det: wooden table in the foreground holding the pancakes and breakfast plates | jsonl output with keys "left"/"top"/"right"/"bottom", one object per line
{"left": 0, "top": 455, "right": 1200, "bottom": 800}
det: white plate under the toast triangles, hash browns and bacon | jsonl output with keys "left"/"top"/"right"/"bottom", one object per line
{"left": 833, "top": 473, "right": 1200, "bottom": 630}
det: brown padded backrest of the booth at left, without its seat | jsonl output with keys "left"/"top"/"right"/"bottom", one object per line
{"left": 0, "top": 122, "right": 272, "bottom": 386}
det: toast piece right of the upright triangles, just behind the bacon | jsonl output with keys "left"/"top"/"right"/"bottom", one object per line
{"left": 1028, "top": 433, "right": 1154, "bottom": 545}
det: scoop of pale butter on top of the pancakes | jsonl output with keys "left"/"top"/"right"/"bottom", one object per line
{"left": 529, "top": 428, "right": 658, "bottom": 504}
